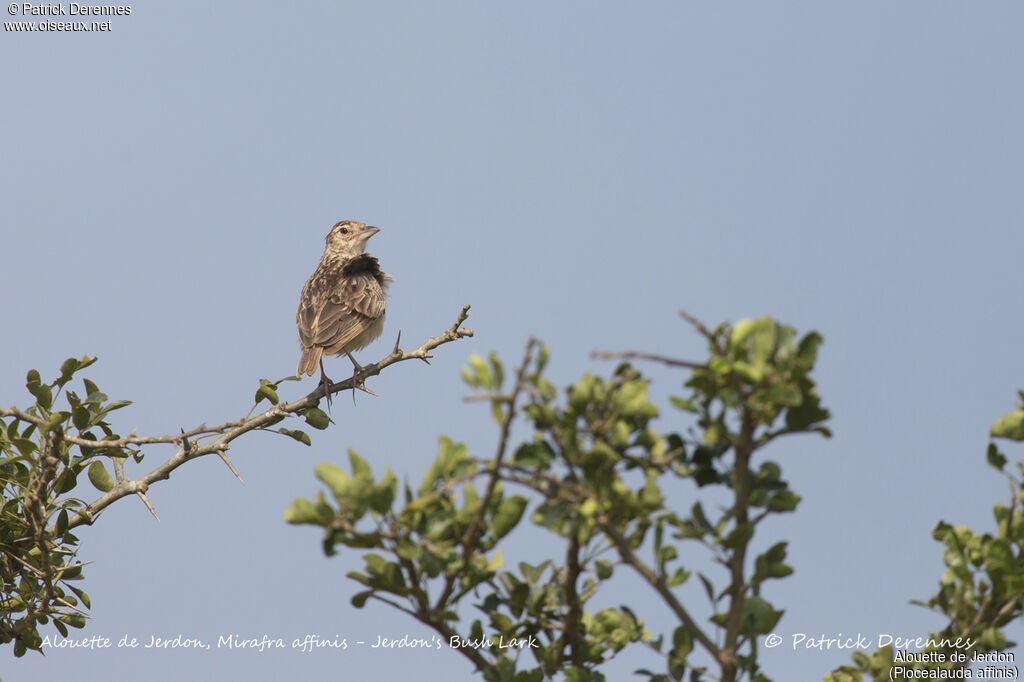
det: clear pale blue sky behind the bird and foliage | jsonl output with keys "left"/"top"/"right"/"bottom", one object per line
{"left": 0, "top": 2, "right": 1024, "bottom": 682}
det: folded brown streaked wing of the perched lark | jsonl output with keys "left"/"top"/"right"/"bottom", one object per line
{"left": 297, "top": 272, "right": 384, "bottom": 349}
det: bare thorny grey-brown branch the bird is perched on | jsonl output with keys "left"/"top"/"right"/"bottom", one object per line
{"left": 0, "top": 305, "right": 473, "bottom": 531}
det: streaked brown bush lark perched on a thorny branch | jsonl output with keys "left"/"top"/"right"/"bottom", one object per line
{"left": 295, "top": 220, "right": 393, "bottom": 408}
